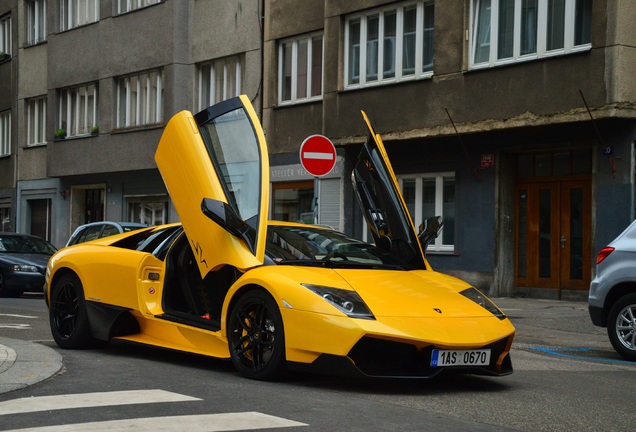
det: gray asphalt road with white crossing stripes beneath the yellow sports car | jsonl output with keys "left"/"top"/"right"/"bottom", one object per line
{"left": 0, "top": 299, "right": 636, "bottom": 432}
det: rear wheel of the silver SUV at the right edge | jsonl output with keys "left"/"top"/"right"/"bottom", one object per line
{"left": 607, "top": 293, "right": 636, "bottom": 361}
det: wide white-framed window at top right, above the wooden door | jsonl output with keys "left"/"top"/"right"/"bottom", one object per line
{"left": 470, "top": 0, "right": 592, "bottom": 69}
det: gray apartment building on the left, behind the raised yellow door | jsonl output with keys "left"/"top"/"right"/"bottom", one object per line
{"left": 0, "top": 0, "right": 262, "bottom": 246}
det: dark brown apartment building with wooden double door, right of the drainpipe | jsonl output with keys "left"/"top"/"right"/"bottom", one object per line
{"left": 263, "top": 0, "right": 636, "bottom": 299}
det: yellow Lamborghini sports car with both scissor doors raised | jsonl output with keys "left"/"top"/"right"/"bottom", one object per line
{"left": 45, "top": 96, "right": 515, "bottom": 380}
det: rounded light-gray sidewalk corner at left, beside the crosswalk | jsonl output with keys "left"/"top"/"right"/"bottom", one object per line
{"left": 0, "top": 337, "right": 62, "bottom": 394}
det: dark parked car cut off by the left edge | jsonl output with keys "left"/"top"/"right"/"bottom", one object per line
{"left": 0, "top": 232, "right": 57, "bottom": 297}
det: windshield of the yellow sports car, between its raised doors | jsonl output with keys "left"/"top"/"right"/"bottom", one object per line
{"left": 265, "top": 225, "right": 413, "bottom": 270}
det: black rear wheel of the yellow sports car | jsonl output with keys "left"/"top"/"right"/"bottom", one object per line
{"left": 49, "top": 273, "right": 91, "bottom": 348}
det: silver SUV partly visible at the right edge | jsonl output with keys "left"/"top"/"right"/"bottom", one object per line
{"left": 588, "top": 221, "right": 636, "bottom": 361}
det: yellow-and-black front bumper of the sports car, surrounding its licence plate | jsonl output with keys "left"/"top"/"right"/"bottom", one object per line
{"left": 282, "top": 309, "right": 515, "bottom": 378}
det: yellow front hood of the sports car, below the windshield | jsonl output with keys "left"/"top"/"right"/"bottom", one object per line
{"left": 336, "top": 269, "right": 493, "bottom": 318}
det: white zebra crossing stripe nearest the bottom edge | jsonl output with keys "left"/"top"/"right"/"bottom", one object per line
{"left": 1, "top": 412, "right": 308, "bottom": 432}
